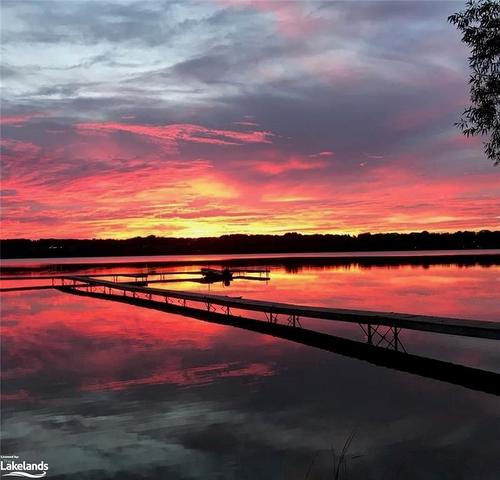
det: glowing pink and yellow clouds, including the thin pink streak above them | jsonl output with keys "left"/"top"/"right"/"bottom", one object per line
{"left": 2, "top": 123, "right": 499, "bottom": 238}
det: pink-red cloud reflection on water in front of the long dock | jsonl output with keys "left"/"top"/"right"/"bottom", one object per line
{"left": 2, "top": 291, "right": 292, "bottom": 401}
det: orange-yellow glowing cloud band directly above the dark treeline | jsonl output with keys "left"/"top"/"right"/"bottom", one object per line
{"left": 2, "top": 149, "right": 500, "bottom": 238}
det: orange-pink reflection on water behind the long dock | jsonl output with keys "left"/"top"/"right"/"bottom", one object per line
{"left": 154, "top": 265, "right": 500, "bottom": 321}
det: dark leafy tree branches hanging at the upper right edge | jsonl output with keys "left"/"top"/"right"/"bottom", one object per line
{"left": 448, "top": 0, "right": 500, "bottom": 165}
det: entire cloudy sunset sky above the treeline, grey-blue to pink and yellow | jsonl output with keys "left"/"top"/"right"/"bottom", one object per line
{"left": 1, "top": 0, "right": 500, "bottom": 238}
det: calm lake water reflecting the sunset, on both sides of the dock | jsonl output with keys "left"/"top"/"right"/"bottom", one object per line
{"left": 1, "top": 256, "right": 500, "bottom": 480}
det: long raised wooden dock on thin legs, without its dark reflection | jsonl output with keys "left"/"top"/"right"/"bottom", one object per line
{"left": 62, "top": 275, "right": 500, "bottom": 342}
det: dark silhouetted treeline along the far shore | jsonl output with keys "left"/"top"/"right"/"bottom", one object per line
{"left": 0, "top": 230, "right": 500, "bottom": 258}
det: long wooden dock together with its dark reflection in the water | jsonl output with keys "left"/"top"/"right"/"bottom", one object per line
{"left": 4, "top": 271, "right": 500, "bottom": 395}
